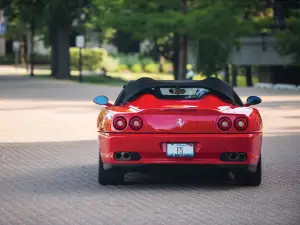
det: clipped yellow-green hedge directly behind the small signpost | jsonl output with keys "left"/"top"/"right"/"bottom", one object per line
{"left": 70, "top": 48, "right": 107, "bottom": 71}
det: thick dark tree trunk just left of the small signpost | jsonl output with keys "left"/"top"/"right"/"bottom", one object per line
{"left": 51, "top": 23, "right": 70, "bottom": 79}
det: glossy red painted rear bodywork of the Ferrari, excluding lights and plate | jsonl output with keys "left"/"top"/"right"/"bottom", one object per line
{"left": 97, "top": 94, "right": 262, "bottom": 165}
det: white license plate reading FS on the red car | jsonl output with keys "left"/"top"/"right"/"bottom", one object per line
{"left": 167, "top": 143, "right": 194, "bottom": 157}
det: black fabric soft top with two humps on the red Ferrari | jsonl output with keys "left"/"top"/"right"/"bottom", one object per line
{"left": 115, "top": 77, "right": 244, "bottom": 106}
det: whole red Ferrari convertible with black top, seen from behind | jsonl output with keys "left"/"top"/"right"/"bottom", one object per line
{"left": 94, "top": 78, "right": 262, "bottom": 186}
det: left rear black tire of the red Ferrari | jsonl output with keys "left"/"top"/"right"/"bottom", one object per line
{"left": 98, "top": 153, "right": 124, "bottom": 185}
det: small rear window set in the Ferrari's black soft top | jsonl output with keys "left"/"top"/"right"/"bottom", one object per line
{"left": 152, "top": 87, "right": 210, "bottom": 99}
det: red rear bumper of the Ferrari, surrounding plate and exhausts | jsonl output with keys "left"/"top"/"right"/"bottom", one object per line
{"left": 99, "top": 133, "right": 262, "bottom": 168}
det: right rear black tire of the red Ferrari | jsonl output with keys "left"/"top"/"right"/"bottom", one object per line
{"left": 234, "top": 156, "right": 262, "bottom": 186}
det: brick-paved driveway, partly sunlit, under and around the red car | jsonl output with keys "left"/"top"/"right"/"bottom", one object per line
{"left": 0, "top": 76, "right": 300, "bottom": 225}
